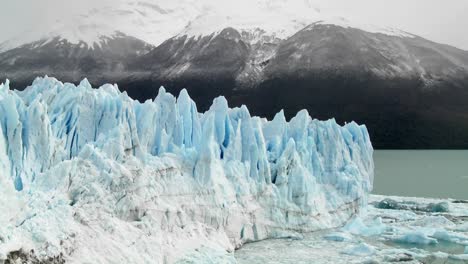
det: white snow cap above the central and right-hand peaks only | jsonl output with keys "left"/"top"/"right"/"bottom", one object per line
{"left": 179, "top": 1, "right": 413, "bottom": 43}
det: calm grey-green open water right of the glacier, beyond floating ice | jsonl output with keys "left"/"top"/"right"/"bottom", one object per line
{"left": 373, "top": 150, "right": 468, "bottom": 200}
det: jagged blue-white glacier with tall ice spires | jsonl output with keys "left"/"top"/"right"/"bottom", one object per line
{"left": 0, "top": 76, "right": 374, "bottom": 263}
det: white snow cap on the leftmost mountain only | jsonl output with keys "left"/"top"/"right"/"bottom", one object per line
{"left": 0, "top": 0, "right": 201, "bottom": 51}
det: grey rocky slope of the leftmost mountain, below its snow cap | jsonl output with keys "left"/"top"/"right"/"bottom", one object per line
{"left": 0, "top": 33, "right": 152, "bottom": 83}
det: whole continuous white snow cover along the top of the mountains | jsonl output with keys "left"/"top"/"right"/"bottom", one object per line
{"left": 0, "top": 0, "right": 407, "bottom": 51}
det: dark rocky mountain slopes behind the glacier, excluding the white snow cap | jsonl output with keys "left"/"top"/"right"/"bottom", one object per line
{"left": 0, "top": 4, "right": 468, "bottom": 148}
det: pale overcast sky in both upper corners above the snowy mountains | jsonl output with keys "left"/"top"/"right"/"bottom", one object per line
{"left": 0, "top": 0, "right": 468, "bottom": 50}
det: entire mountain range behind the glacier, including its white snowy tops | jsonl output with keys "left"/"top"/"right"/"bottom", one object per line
{"left": 0, "top": 0, "right": 468, "bottom": 148}
